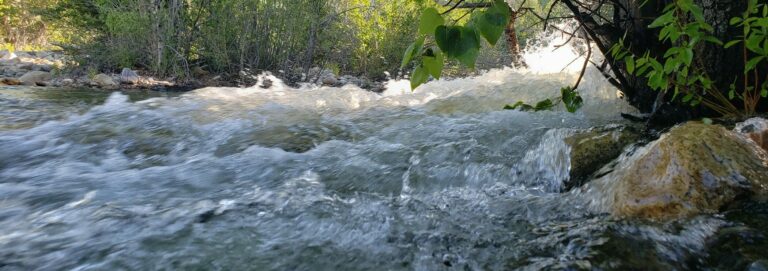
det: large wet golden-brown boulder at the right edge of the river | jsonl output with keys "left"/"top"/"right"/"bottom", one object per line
{"left": 586, "top": 122, "right": 768, "bottom": 220}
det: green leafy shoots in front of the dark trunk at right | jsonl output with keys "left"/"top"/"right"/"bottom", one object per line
{"left": 610, "top": 0, "right": 768, "bottom": 115}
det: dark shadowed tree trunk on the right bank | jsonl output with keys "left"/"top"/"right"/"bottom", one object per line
{"left": 561, "top": 0, "right": 764, "bottom": 124}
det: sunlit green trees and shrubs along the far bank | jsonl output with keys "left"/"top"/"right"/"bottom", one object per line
{"left": 0, "top": 0, "right": 528, "bottom": 80}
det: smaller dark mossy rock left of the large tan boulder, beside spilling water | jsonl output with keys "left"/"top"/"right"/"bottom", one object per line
{"left": 564, "top": 126, "right": 640, "bottom": 191}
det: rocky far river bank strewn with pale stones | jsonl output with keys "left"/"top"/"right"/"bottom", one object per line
{"left": 0, "top": 51, "right": 384, "bottom": 93}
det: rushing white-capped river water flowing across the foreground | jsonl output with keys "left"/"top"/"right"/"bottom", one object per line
{"left": 0, "top": 45, "right": 768, "bottom": 270}
